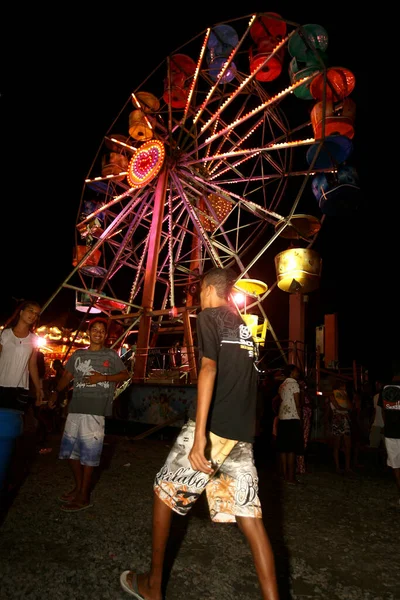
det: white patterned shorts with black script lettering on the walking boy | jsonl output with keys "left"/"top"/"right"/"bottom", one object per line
{"left": 154, "top": 421, "right": 262, "bottom": 523}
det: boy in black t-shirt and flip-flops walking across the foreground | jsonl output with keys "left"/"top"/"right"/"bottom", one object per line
{"left": 120, "top": 267, "right": 278, "bottom": 600}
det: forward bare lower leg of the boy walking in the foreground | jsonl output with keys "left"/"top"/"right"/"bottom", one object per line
{"left": 236, "top": 517, "right": 279, "bottom": 600}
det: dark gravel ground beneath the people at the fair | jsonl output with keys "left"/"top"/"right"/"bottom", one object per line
{"left": 0, "top": 429, "right": 400, "bottom": 600}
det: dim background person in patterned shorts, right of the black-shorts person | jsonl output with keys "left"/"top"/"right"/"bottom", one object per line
{"left": 330, "top": 379, "right": 352, "bottom": 473}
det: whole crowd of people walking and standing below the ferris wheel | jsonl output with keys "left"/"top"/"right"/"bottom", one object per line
{"left": 0, "top": 267, "right": 400, "bottom": 600}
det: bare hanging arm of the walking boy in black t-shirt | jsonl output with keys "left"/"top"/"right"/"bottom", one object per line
{"left": 189, "top": 357, "right": 217, "bottom": 474}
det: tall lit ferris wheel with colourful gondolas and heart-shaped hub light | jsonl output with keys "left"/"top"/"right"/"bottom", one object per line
{"left": 42, "top": 13, "right": 359, "bottom": 379}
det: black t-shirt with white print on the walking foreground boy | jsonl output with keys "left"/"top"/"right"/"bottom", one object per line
{"left": 190, "top": 306, "right": 258, "bottom": 442}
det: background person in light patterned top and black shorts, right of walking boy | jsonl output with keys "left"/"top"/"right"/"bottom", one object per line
{"left": 276, "top": 364, "right": 304, "bottom": 485}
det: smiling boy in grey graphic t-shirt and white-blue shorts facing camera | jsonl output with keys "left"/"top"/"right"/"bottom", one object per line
{"left": 50, "top": 317, "right": 129, "bottom": 512}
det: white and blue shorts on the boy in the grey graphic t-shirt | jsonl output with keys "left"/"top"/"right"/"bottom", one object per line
{"left": 58, "top": 413, "right": 105, "bottom": 467}
